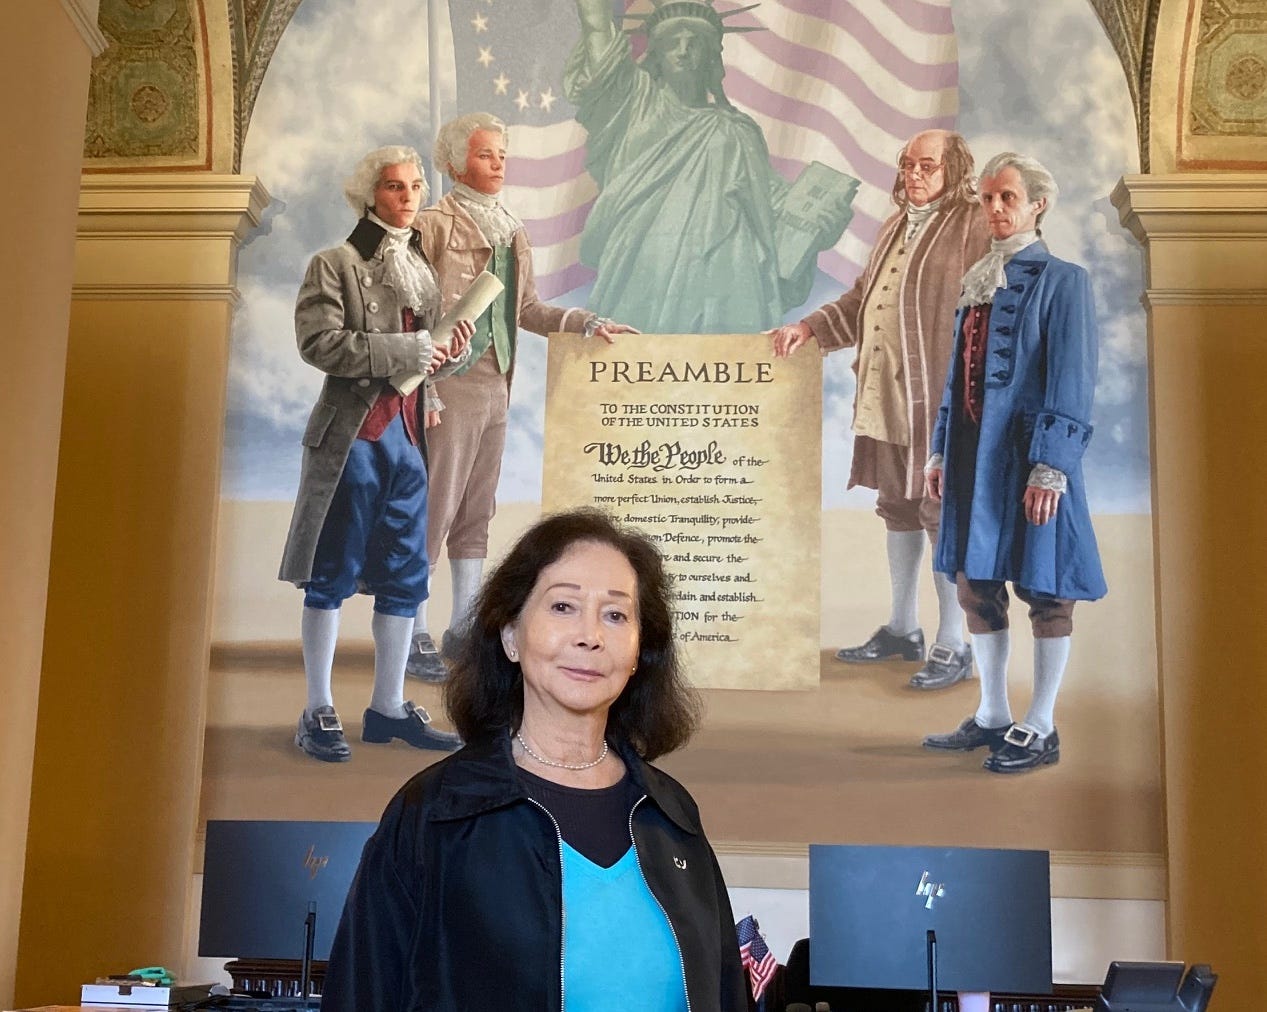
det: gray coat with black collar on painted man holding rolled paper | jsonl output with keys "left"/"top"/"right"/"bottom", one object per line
{"left": 277, "top": 218, "right": 461, "bottom": 586}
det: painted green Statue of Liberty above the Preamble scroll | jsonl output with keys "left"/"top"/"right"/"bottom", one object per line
{"left": 564, "top": 0, "right": 858, "bottom": 333}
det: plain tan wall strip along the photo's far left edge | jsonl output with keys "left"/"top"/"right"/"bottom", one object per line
{"left": 0, "top": 3, "right": 91, "bottom": 1008}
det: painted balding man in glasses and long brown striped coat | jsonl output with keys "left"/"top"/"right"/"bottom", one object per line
{"left": 774, "top": 130, "right": 990, "bottom": 689}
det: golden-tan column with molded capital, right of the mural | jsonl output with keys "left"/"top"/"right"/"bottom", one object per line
{"left": 1112, "top": 174, "right": 1267, "bottom": 1008}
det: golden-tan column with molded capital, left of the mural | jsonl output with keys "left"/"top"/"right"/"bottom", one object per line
{"left": 15, "top": 172, "right": 267, "bottom": 1004}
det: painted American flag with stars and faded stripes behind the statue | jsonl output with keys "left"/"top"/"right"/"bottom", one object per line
{"left": 432, "top": 0, "right": 959, "bottom": 309}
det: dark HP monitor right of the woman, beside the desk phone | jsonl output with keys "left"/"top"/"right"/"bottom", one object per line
{"left": 810, "top": 845, "right": 1052, "bottom": 994}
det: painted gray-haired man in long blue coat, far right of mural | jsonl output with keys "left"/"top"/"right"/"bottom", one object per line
{"left": 924, "top": 152, "right": 1107, "bottom": 773}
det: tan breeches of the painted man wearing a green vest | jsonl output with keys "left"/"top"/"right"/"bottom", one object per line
{"left": 427, "top": 351, "right": 511, "bottom": 559}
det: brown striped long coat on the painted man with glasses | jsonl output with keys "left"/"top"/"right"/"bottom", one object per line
{"left": 805, "top": 204, "right": 990, "bottom": 499}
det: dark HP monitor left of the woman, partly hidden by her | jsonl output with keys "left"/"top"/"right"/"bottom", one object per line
{"left": 198, "top": 819, "right": 378, "bottom": 959}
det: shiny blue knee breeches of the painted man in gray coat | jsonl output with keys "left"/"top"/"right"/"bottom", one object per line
{"left": 304, "top": 415, "right": 428, "bottom": 617}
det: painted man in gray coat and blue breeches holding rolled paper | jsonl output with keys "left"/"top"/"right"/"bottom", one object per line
{"left": 279, "top": 146, "right": 473, "bottom": 762}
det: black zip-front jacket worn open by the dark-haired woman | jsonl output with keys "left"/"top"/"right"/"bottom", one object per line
{"left": 322, "top": 736, "right": 748, "bottom": 1012}
